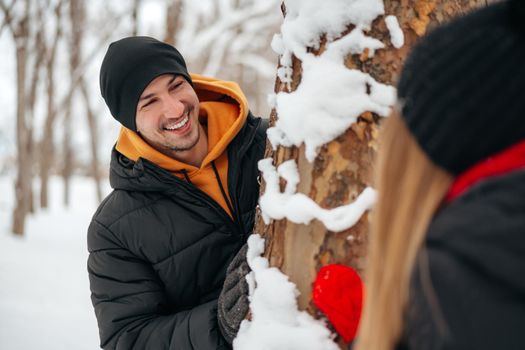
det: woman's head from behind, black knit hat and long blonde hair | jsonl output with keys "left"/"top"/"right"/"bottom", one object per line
{"left": 355, "top": 1, "right": 525, "bottom": 350}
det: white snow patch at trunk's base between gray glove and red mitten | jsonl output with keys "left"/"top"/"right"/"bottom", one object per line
{"left": 233, "top": 234, "right": 339, "bottom": 350}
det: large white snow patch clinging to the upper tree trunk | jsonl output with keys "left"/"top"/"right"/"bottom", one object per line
{"left": 268, "top": 0, "right": 399, "bottom": 162}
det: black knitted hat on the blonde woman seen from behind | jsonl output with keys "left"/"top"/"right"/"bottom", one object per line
{"left": 398, "top": 0, "right": 525, "bottom": 175}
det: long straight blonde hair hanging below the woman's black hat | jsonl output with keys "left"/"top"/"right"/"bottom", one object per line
{"left": 354, "top": 113, "right": 453, "bottom": 350}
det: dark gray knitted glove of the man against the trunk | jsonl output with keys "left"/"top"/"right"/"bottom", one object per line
{"left": 217, "top": 244, "right": 251, "bottom": 344}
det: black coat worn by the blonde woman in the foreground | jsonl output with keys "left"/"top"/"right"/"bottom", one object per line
{"left": 399, "top": 170, "right": 525, "bottom": 350}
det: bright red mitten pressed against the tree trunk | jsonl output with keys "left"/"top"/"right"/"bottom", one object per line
{"left": 312, "top": 264, "right": 363, "bottom": 343}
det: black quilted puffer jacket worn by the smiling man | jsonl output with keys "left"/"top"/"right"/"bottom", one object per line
{"left": 88, "top": 115, "right": 266, "bottom": 350}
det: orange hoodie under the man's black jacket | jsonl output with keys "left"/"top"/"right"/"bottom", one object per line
{"left": 116, "top": 74, "right": 248, "bottom": 217}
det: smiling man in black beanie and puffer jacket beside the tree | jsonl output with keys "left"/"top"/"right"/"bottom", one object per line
{"left": 88, "top": 37, "right": 266, "bottom": 350}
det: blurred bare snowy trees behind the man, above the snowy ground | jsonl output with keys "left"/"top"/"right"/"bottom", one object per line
{"left": 0, "top": 0, "right": 282, "bottom": 234}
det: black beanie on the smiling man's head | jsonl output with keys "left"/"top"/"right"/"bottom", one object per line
{"left": 100, "top": 36, "right": 192, "bottom": 131}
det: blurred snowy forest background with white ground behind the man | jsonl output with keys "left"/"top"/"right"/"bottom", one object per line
{"left": 0, "top": 0, "right": 282, "bottom": 350}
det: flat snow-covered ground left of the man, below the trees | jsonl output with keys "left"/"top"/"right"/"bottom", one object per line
{"left": 0, "top": 177, "right": 109, "bottom": 350}
